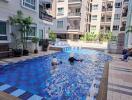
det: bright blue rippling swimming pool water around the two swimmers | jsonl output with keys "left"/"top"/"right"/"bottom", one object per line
{"left": 0, "top": 49, "right": 111, "bottom": 100}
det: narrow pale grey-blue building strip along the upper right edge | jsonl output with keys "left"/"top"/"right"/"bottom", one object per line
{"left": 125, "top": 0, "right": 132, "bottom": 48}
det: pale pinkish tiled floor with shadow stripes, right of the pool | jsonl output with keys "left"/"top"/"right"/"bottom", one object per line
{"left": 107, "top": 55, "right": 132, "bottom": 100}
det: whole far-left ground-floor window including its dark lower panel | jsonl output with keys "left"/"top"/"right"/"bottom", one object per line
{"left": 0, "top": 22, "right": 7, "bottom": 40}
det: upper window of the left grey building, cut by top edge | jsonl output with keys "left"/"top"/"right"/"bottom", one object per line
{"left": 22, "top": 0, "right": 36, "bottom": 10}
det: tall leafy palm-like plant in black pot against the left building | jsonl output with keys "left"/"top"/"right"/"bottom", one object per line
{"left": 9, "top": 11, "right": 32, "bottom": 56}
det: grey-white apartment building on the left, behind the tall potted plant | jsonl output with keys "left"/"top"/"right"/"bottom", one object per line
{"left": 0, "top": 0, "right": 52, "bottom": 49}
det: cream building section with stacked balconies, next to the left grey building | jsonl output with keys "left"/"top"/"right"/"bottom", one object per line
{"left": 53, "top": 0, "right": 87, "bottom": 39}
